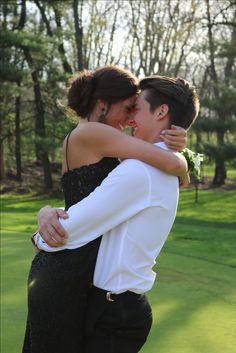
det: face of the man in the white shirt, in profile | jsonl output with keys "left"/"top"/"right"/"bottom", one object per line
{"left": 132, "top": 91, "right": 156, "bottom": 142}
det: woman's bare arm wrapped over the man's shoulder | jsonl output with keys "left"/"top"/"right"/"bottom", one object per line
{"left": 79, "top": 122, "right": 188, "bottom": 176}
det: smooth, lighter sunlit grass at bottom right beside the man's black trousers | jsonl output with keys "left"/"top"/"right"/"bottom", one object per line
{"left": 141, "top": 252, "right": 236, "bottom": 353}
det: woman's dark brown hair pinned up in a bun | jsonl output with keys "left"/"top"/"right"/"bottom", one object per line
{"left": 67, "top": 65, "right": 138, "bottom": 119}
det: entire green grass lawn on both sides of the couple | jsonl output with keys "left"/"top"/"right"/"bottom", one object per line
{"left": 1, "top": 190, "right": 236, "bottom": 353}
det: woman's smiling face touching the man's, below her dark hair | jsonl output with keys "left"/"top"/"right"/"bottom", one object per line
{"left": 102, "top": 95, "right": 137, "bottom": 130}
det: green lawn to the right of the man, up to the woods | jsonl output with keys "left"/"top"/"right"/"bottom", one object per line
{"left": 142, "top": 191, "right": 236, "bottom": 353}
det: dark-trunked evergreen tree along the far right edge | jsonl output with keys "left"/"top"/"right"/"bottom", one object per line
{"left": 203, "top": 0, "right": 236, "bottom": 186}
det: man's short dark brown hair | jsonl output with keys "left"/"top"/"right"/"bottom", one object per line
{"left": 140, "top": 76, "right": 199, "bottom": 129}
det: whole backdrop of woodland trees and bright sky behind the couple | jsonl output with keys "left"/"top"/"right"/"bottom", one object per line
{"left": 0, "top": 0, "right": 236, "bottom": 192}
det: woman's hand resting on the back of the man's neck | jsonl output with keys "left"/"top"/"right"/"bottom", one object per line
{"left": 160, "top": 125, "right": 187, "bottom": 152}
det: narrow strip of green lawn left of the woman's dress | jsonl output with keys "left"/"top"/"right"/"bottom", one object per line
{"left": 0, "top": 197, "right": 63, "bottom": 353}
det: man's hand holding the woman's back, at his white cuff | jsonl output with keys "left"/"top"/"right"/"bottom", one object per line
{"left": 38, "top": 206, "right": 68, "bottom": 247}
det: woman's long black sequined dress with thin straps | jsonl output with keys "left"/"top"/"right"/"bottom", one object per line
{"left": 23, "top": 158, "right": 119, "bottom": 353}
